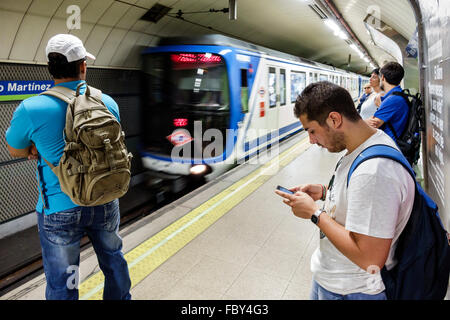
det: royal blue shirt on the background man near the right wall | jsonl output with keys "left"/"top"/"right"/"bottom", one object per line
{"left": 373, "top": 86, "right": 409, "bottom": 141}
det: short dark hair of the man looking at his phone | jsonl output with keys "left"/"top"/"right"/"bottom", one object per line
{"left": 294, "top": 81, "right": 361, "bottom": 126}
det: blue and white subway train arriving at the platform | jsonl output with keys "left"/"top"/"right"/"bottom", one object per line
{"left": 140, "top": 35, "right": 369, "bottom": 185}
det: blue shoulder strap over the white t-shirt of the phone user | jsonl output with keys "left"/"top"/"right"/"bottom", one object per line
{"left": 347, "top": 144, "right": 416, "bottom": 188}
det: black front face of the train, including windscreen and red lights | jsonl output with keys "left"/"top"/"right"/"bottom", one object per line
{"left": 142, "top": 52, "right": 231, "bottom": 158}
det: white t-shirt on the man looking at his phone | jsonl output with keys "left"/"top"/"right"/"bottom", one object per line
{"left": 311, "top": 130, "right": 415, "bottom": 295}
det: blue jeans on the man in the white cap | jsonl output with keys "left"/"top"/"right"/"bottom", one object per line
{"left": 37, "top": 199, "right": 131, "bottom": 300}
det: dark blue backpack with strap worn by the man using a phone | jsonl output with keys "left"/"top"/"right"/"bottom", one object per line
{"left": 347, "top": 145, "right": 450, "bottom": 300}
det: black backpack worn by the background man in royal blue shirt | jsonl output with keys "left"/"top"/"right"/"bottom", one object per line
{"left": 386, "top": 89, "right": 425, "bottom": 166}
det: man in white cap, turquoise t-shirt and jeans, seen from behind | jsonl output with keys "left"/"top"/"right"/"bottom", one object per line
{"left": 6, "top": 34, "right": 131, "bottom": 300}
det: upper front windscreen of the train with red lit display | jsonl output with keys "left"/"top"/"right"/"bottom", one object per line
{"left": 146, "top": 53, "right": 230, "bottom": 111}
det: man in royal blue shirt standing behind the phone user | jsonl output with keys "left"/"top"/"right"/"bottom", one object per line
{"left": 366, "top": 62, "right": 409, "bottom": 141}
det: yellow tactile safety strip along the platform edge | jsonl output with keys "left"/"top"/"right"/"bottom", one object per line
{"left": 79, "top": 138, "right": 310, "bottom": 300}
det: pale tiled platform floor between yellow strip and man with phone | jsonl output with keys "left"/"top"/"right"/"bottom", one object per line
{"left": 132, "top": 142, "right": 340, "bottom": 300}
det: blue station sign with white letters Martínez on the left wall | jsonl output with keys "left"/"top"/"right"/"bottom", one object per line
{"left": 0, "top": 80, "right": 55, "bottom": 101}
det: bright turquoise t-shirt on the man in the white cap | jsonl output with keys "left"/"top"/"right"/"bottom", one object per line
{"left": 6, "top": 80, "right": 120, "bottom": 214}
